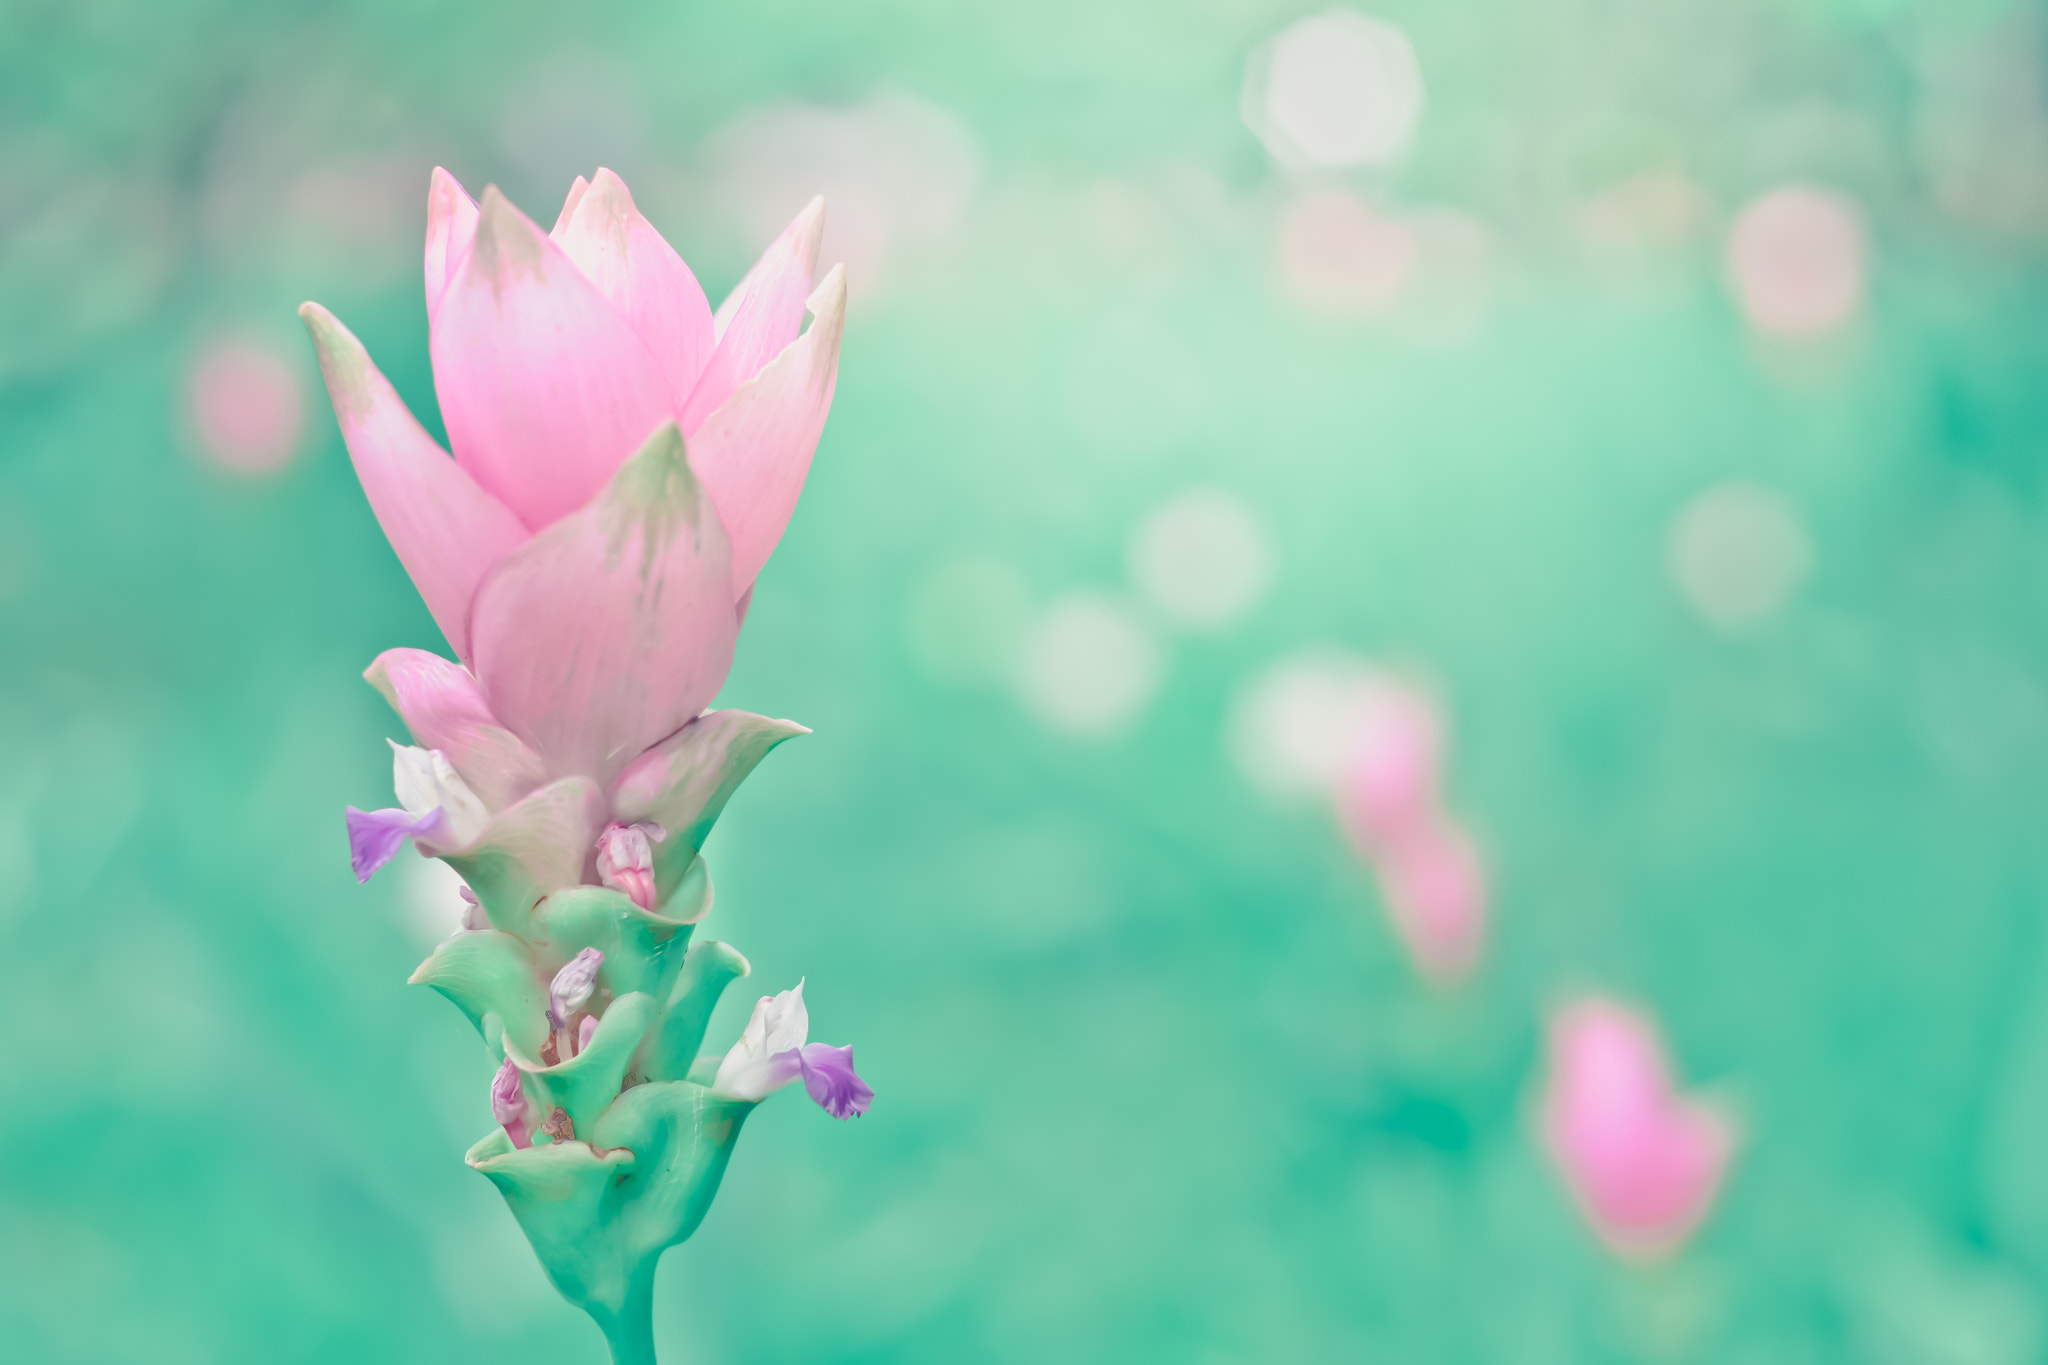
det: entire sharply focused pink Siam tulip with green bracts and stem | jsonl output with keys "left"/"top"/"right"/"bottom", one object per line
{"left": 299, "top": 170, "right": 872, "bottom": 1365}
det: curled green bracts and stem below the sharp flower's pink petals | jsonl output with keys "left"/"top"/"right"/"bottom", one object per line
{"left": 391, "top": 712, "right": 823, "bottom": 1365}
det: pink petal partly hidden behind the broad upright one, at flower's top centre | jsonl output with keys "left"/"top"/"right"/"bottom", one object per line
{"left": 553, "top": 168, "right": 713, "bottom": 411}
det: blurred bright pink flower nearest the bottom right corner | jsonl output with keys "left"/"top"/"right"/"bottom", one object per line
{"left": 1542, "top": 1001, "right": 1735, "bottom": 1257}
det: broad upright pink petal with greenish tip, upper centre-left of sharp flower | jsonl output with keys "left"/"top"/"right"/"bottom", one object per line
{"left": 430, "top": 186, "right": 670, "bottom": 530}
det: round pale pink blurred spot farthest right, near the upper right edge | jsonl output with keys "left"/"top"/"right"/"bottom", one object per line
{"left": 1729, "top": 184, "right": 1864, "bottom": 338}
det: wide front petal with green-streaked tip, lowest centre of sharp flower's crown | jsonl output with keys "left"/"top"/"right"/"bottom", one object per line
{"left": 471, "top": 422, "right": 737, "bottom": 780}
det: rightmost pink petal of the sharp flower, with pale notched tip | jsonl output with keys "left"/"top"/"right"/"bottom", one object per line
{"left": 690, "top": 266, "right": 846, "bottom": 600}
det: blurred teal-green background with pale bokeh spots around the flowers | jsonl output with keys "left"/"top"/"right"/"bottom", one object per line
{"left": 0, "top": 0, "right": 2048, "bottom": 1365}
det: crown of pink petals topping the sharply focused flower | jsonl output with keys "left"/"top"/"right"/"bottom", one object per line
{"left": 299, "top": 170, "right": 846, "bottom": 789}
